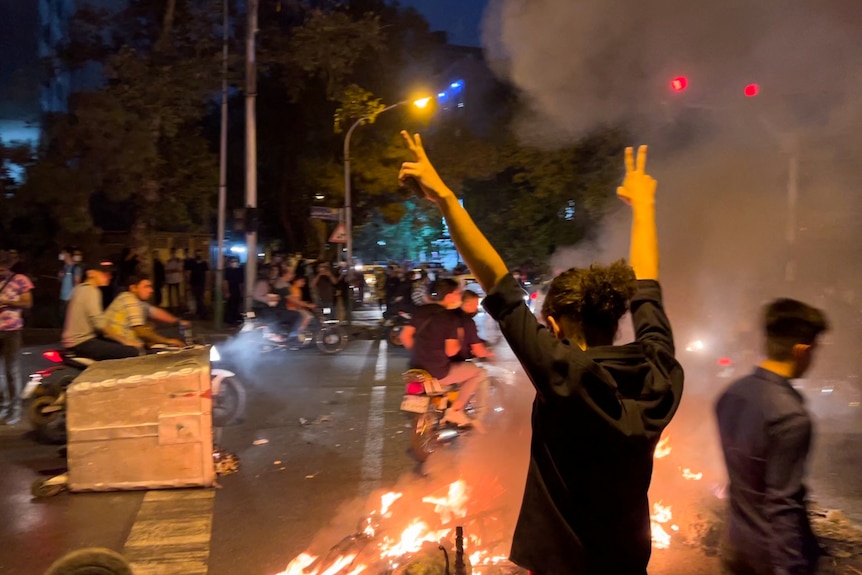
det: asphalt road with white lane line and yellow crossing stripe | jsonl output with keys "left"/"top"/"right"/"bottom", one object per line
{"left": 0, "top": 326, "right": 862, "bottom": 575}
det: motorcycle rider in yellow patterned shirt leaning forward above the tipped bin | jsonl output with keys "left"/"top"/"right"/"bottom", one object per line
{"left": 104, "top": 275, "right": 190, "bottom": 351}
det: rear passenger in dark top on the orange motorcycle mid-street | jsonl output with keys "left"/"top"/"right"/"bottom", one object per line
{"left": 401, "top": 278, "right": 488, "bottom": 432}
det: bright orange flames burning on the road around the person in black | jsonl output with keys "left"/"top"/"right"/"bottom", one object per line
{"left": 278, "top": 436, "right": 716, "bottom": 575}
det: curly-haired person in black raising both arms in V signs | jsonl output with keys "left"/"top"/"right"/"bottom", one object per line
{"left": 399, "top": 132, "right": 683, "bottom": 575}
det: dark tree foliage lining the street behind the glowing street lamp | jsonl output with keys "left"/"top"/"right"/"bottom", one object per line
{"left": 10, "top": 0, "right": 622, "bottom": 274}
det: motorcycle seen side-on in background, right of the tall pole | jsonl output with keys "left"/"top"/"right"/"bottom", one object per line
{"left": 239, "top": 308, "right": 349, "bottom": 354}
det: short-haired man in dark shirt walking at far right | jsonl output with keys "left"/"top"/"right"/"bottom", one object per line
{"left": 715, "top": 299, "right": 828, "bottom": 575}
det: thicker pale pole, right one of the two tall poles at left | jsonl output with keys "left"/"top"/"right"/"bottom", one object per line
{"left": 245, "top": 0, "right": 258, "bottom": 311}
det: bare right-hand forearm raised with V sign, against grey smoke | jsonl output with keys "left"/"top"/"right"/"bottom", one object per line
{"left": 617, "top": 146, "right": 658, "bottom": 280}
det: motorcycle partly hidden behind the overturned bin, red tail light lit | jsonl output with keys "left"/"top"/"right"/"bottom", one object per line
{"left": 21, "top": 338, "right": 246, "bottom": 443}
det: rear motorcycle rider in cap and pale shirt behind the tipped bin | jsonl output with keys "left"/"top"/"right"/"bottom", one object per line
{"left": 61, "top": 261, "right": 140, "bottom": 361}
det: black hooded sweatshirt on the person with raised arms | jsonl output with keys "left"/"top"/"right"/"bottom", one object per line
{"left": 483, "top": 276, "right": 683, "bottom": 575}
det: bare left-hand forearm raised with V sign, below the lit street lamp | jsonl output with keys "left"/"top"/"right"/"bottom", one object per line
{"left": 398, "top": 132, "right": 509, "bottom": 292}
